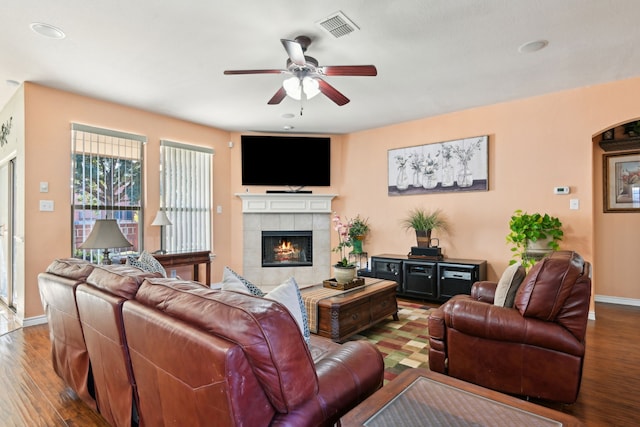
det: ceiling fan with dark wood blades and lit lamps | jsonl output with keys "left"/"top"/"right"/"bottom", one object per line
{"left": 224, "top": 36, "right": 378, "bottom": 105}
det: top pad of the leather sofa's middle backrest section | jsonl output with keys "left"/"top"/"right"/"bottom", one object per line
{"left": 87, "top": 264, "right": 161, "bottom": 299}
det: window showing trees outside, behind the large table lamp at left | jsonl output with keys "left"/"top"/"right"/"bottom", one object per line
{"left": 71, "top": 123, "right": 146, "bottom": 262}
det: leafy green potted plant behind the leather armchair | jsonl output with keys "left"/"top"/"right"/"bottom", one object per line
{"left": 507, "top": 209, "right": 564, "bottom": 268}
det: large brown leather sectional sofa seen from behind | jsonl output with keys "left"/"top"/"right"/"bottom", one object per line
{"left": 38, "top": 259, "right": 384, "bottom": 426}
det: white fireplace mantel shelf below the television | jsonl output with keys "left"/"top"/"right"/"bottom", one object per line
{"left": 236, "top": 193, "right": 336, "bottom": 213}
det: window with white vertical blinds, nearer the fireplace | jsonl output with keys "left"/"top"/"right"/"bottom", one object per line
{"left": 160, "top": 140, "right": 214, "bottom": 252}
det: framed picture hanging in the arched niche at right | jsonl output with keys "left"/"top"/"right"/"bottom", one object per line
{"left": 603, "top": 151, "right": 640, "bottom": 212}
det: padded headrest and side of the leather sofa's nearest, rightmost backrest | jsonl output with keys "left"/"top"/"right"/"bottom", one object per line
{"left": 136, "top": 279, "right": 318, "bottom": 413}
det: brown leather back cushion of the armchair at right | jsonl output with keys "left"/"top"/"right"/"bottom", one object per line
{"left": 515, "top": 251, "right": 584, "bottom": 321}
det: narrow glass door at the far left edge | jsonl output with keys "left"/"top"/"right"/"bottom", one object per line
{"left": 0, "top": 159, "right": 15, "bottom": 308}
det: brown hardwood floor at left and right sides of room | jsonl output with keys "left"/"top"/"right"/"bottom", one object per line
{"left": 0, "top": 303, "right": 640, "bottom": 427}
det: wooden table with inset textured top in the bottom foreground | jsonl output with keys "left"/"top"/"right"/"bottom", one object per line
{"left": 340, "top": 369, "right": 585, "bottom": 427}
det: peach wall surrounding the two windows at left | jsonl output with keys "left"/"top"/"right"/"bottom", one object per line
{"left": 25, "top": 83, "right": 231, "bottom": 318}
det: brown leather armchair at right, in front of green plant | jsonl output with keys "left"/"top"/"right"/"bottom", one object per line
{"left": 429, "top": 251, "right": 591, "bottom": 403}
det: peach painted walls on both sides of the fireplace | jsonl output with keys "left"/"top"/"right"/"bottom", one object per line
{"left": 16, "top": 79, "right": 640, "bottom": 317}
